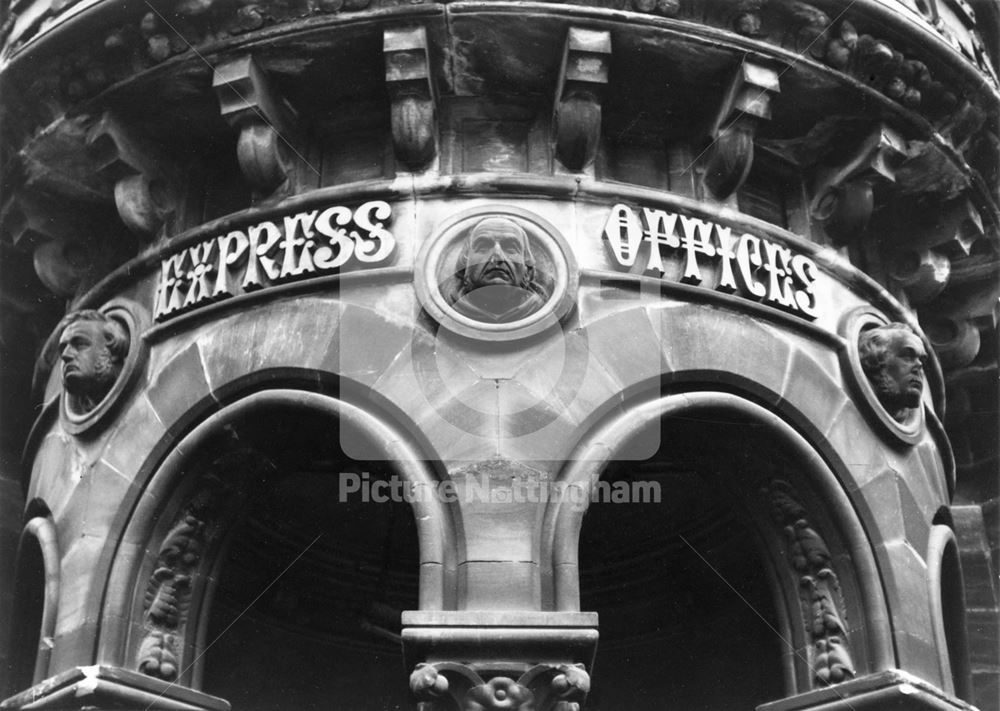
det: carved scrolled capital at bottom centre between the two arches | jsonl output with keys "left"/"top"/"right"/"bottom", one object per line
{"left": 410, "top": 662, "right": 590, "bottom": 711}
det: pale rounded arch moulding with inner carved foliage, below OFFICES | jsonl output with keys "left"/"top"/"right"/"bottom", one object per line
{"left": 542, "top": 391, "right": 895, "bottom": 692}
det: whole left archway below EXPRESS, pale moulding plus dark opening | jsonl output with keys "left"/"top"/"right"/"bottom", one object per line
{"left": 100, "top": 389, "right": 454, "bottom": 709}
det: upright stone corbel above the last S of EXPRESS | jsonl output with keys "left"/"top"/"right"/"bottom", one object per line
{"left": 382, "top": 27, "right": 437, "bottom": 171}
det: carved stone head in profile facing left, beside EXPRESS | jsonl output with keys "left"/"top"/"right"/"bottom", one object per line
{"left": 59, "top": 309, "right": 129, "bottom": 414}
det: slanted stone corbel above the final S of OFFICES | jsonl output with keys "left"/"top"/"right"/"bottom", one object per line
{"left": 809, "top": 124, "right": 906, "bottom": 244}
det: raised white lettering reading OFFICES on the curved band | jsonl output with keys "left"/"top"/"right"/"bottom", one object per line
{"left": 603, "top": 204, "right": 819, "bottom": 320}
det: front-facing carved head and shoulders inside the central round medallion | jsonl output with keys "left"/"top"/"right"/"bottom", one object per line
{"left": 441, "top": 217, "right": 553, "bottom": 323}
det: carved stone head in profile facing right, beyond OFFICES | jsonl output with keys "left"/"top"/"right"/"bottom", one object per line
{"left": 858, "top": 322, "right": 927, "bottom": 422}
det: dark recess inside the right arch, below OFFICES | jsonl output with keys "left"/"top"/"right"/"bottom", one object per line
{"left": 580, "top": 408, "right": 796, "bottom": 711}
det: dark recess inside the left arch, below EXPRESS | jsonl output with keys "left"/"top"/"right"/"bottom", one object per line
{"left": 201, "top": 404, "right": 420, "bottom": 711}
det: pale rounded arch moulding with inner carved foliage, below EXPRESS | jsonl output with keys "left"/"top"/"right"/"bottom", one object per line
{"left": 98, "top": 386, "right": 455, "bottom": 685}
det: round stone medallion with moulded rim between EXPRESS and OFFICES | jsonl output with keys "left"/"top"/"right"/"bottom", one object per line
{"left": 414, "top": 205, "right": 579, "bottom": 341}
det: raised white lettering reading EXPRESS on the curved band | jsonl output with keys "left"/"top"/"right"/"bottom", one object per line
{"left": 154, "top": 200, "right": 396, "bottom": 321}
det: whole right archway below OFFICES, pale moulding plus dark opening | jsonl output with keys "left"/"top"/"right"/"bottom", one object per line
{"left": 546, "top": 392, "right": 893, "bottom": 709}
